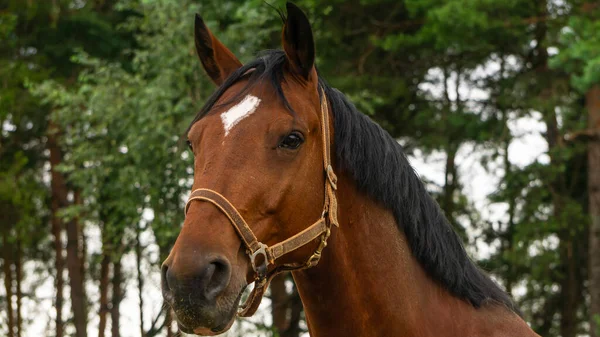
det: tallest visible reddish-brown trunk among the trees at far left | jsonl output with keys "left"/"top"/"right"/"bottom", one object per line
{"left": 46, "top": 122, "right": 67, "bottom": 337}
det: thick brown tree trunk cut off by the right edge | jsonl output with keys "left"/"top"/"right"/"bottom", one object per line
{"left": 586, "top": 85, "right": 600, "bottom": 337}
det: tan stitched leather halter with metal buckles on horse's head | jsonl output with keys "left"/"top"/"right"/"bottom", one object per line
{"left": 185, "top": 88, "right": 339, "bottom": 317}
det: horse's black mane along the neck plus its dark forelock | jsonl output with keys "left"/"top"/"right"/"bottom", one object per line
{"left": 190, "top": 50, "right": 516, "bottom": 311}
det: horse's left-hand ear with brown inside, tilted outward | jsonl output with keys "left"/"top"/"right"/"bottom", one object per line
{"left": 194, "top": 14, "right": 242, "bottom": 85}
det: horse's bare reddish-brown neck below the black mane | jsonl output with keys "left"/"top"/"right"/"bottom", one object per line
{"left": 294, "top": 172, "right": 530, "bottom": 337}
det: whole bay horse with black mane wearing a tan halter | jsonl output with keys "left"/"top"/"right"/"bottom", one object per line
{"left": 162, "top": 3, "right": 537, "bottom": 337}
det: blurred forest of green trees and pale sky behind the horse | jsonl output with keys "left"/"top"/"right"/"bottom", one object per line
{"left": 0, "top": 0, "right": 600, "bottom": 337}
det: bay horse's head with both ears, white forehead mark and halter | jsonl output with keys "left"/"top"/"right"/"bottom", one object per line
{"left": 162, "top": 3, "right": 337, "bottom": 335}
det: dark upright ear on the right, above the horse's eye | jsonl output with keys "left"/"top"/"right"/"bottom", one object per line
{"left": 282, "top": 2, "right": 315, "bottom": 80}
